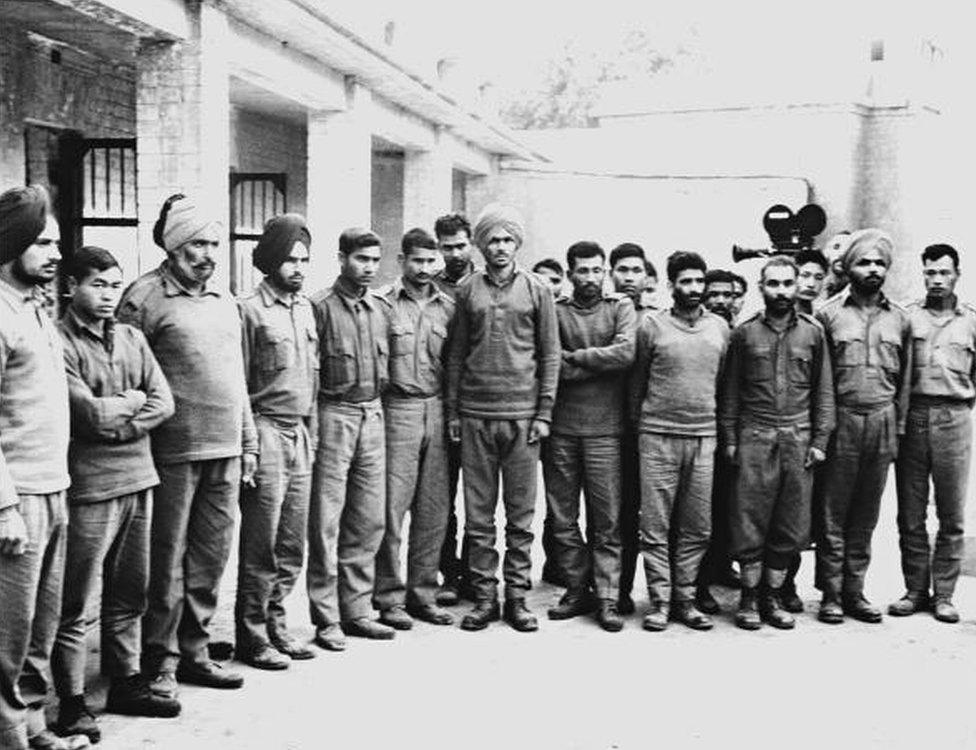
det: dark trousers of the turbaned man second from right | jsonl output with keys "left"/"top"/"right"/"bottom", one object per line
{"left": 817, "top": 405, "right": 898, "bottom": 598}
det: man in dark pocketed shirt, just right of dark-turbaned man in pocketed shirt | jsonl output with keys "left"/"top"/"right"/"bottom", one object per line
{"left": 307, "top": 228, "right": 395, "bottom": 651}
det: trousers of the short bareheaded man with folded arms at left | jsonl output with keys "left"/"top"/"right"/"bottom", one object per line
{"left": 51, "top": 490, "right": 153, "bottom": 698}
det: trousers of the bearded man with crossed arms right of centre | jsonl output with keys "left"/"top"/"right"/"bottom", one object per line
{"left": 542, "top": 435, "right": 620, "bottom": 600}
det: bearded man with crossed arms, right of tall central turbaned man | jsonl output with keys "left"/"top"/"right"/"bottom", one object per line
{"left": 542, "top": 241, "right": 637, "bottom": 632}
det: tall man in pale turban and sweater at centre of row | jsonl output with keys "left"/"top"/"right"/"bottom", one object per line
{"left": 447, "top": 204, "right": 560, "bottom": 632}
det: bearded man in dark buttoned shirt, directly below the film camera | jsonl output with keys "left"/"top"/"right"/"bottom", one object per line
{"left": 719, "top": 256, "right": 834, "bottom": 630}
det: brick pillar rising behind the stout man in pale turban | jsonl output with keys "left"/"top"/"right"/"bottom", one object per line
{"left": 136, "top": 2, "right": 230, "bottom": 286}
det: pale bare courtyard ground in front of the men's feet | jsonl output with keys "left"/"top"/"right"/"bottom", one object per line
{"left": 78, "top": 476, "right": 976, "bottom": 750}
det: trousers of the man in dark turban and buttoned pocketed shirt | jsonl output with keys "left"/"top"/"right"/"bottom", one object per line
{"left": 234, "top": 415, "right": 312, "bottom": 654}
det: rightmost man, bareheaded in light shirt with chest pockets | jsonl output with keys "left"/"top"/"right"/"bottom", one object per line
{"left": 888, "top": 244, "right": 976, "bottom": 623}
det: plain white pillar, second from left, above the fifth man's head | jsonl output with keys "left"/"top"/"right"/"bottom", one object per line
{"left": 306, "top": 77, "right": 372, "bottom": 292}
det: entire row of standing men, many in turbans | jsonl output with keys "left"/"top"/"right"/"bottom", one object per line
{"left": 0, "top": 187, "right": 976, "bottom": 750}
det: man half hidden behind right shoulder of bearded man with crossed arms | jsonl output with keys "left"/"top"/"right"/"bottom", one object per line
{"left": 610, "top": 242, "right": 657, "bottom": 615}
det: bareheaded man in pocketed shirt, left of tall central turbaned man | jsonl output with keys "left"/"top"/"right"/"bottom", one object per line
{"left": 373, "top": 229, "right": 454, "bottom": 630}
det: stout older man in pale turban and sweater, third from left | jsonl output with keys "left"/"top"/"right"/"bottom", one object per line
{"left": 118, "top": 196, "right": 258, "bottom": 698}
